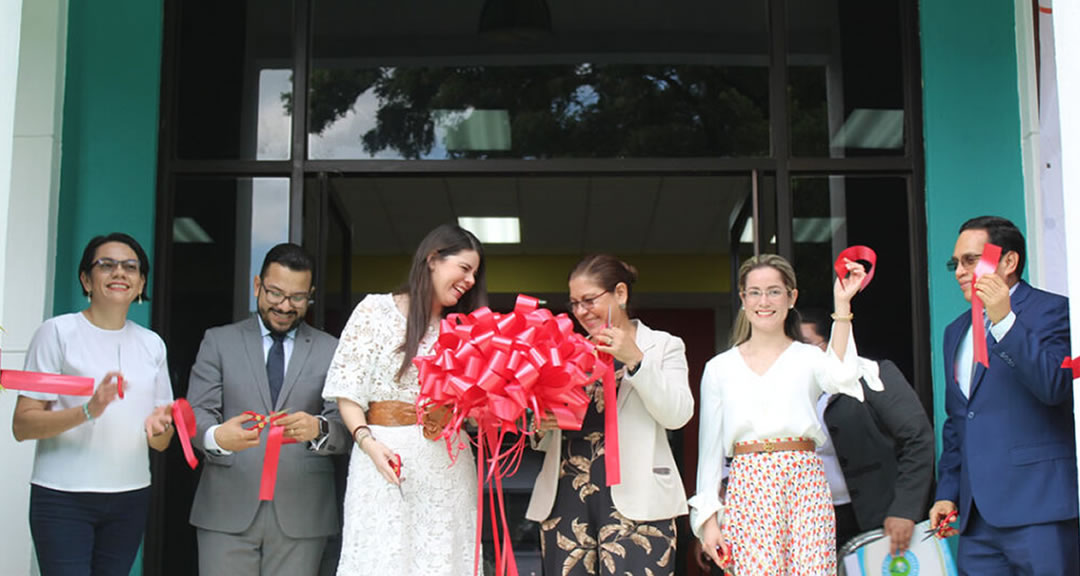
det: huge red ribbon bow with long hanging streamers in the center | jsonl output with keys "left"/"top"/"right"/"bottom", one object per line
{"left": 413, "top": 294, "right": 619, "bottom": 576}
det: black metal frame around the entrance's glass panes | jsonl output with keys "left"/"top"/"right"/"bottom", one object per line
{"left": 145, "top": 0, "right": 933, "bottom": 575}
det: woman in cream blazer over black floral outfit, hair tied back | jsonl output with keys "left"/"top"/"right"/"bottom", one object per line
{"left": 526, "top": 254, "right": 693, "bottom": 576}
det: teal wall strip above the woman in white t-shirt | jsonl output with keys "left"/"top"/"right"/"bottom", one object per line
{"left": 53, "top": 0, "right": 163, "bottom": 325}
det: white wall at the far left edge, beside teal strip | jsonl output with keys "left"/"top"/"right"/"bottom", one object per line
{"left": 0, "top": 0, "right": 67, "bottom": 575}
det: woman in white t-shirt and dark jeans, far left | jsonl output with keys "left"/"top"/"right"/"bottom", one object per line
{"left": 12, "top": 232, "right": 173, "bottom": 576}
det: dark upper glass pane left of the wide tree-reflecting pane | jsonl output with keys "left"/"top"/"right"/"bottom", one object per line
{"left": 176, "top": 0, "right": 293, "bottom": 160}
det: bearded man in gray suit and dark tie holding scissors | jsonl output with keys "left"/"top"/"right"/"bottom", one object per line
{"left": 188, "top": 244, "right": 351, "bottom": 576}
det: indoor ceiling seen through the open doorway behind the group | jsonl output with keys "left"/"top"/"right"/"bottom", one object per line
{"left": 330, "top": 176, "right": 751, "bottom": 255}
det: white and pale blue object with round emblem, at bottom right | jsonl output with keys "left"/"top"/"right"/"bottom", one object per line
{"left": 837, "top": 520, "right": 957, "bottom": 576}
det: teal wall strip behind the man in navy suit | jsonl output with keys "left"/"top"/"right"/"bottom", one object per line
{"left": 919, "top": 0, "right": 1025, "bottom": 456}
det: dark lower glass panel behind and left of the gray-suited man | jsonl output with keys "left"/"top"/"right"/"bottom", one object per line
{"left": 159, "top": 173, "right": 288, "bottom": 574}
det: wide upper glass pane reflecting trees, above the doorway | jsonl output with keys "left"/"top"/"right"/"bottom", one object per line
{"left": 308, "top": 0, "right": 769, "bottom": 160}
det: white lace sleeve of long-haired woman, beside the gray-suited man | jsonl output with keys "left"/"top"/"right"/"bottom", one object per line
{"left": 323, "top": 296, "right": 388, "bottom": 412}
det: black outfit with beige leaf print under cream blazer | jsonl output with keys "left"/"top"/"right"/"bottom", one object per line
{"left": 540, "top": 431, "right": 675, "bottom": 576}
